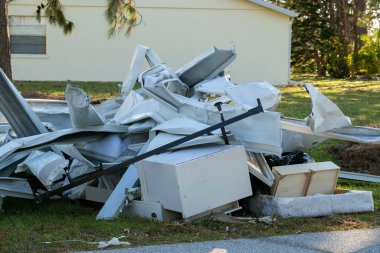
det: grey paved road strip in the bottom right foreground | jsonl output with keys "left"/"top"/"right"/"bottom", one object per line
{"left": 79, "top": 228, "right": 380, "bottom": 253}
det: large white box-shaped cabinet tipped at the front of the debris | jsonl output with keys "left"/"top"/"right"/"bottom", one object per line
{"left": 137, "top": 145, "right": 252, "bottom": 218}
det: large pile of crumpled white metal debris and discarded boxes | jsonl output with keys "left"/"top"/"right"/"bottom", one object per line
{"left": 0, "top": 45, "right": 380, "bottom": 220}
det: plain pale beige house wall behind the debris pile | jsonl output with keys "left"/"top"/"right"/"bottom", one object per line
{"left": 9, "top": 0, "right": 291, "bottom": 85}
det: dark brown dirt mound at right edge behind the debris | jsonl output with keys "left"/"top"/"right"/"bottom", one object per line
{"left": 329, "top": 143, "right": 380, "bottom": 176}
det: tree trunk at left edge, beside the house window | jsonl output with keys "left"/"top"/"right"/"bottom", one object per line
{"left": 0, "top": 0, "right": 12, "bottom": 79}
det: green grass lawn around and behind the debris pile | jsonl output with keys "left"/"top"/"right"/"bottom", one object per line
{"left": 0, "top": 75, "right": 380, "bottom": 252}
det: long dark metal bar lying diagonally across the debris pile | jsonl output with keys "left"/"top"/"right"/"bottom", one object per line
{"left": 31, "top": 99, "right": 264, "bottom": 202}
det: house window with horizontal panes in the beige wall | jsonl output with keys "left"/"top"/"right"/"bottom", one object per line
{"left": 9, "top": 16, "right": 46, "bottom": 54}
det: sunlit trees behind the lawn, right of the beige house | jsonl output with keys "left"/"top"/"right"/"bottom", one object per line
{"left": 269, "top": 0, "right": 380, "bottom": 78}
